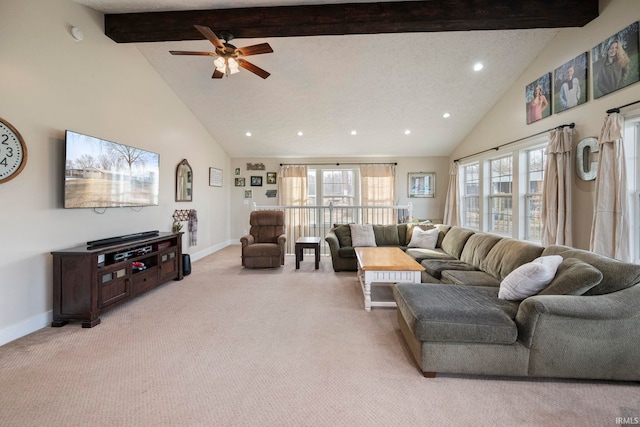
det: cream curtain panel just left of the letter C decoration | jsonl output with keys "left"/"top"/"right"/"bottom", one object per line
{"left": 542, "top": 127, "right": 573, "bottom": 246}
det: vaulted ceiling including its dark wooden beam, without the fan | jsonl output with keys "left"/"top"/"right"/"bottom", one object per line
{"left": 75, "top": 0, "right": 598, "bottom": 157}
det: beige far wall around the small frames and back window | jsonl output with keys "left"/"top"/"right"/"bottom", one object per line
{"left": 230, "top": 157, "right": 449, "bottom": 240}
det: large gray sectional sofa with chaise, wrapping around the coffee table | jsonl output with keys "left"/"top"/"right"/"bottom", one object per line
{"left": 327, "top": 224, "right": 640, "bottom": 381}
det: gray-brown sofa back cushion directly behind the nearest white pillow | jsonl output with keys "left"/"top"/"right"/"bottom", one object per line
{"left": 538, "top": 258, "right": 602, "bottom": 295}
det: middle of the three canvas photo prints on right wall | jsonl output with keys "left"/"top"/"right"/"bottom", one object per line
{"left": 553, "top": 52, "right": 589, "bottom": 113}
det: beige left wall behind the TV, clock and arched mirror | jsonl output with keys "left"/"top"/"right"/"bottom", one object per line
{"left": 0, "top": 0, "right": 230, "bottom": 344}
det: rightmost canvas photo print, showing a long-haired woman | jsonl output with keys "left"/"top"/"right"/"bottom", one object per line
{"left": 591, "top": 22, "right": 640, "bottom": 98}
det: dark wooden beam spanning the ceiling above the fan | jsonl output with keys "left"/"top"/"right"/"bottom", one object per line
{"left": 104, "top": 0, "right": 598, "bottom": 43}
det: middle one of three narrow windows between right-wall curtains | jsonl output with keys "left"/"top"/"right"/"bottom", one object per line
{"left": 488, "top": 155, "right": 513, "bottom": 235}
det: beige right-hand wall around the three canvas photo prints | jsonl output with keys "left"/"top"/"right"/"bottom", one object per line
{"left": 451, "top": 0, "right": 640, "bottom": 249}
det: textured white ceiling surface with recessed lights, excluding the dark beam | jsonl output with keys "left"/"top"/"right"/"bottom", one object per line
{"left": 76, "top": 0, "right": 557, "bottom": 157}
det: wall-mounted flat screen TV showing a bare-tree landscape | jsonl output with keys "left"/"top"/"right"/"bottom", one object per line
{"left": 64, "top": 130, "right": 160, "bottom": 208}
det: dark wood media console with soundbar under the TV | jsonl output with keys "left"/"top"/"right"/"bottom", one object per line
{"left": 51, "top": 233, "right": 183, "bottom": 328}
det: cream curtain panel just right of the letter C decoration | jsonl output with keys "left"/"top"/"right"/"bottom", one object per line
{"left": 590, "top": 113, "right": 631, "bottom": 261}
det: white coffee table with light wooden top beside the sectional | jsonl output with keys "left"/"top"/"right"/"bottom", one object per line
{"left": 355, "top": 247, "right": 424, "bottom": 311}
